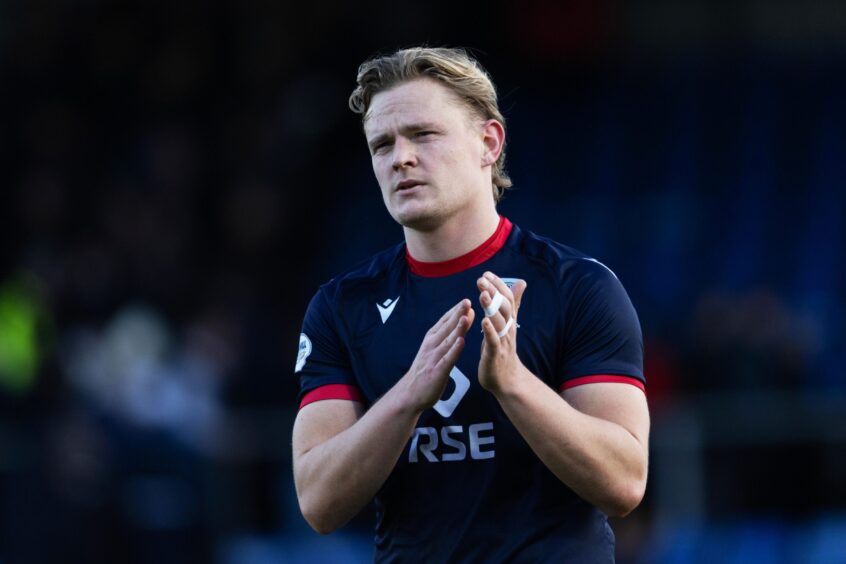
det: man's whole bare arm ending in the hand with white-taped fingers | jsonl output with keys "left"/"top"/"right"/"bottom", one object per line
{"left": 479, "top": 273, "right": 649, "bottom": 516}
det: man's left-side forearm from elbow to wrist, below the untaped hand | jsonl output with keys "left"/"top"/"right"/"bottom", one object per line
{"left": 294, "top": 380, "right": 420, "bottom": 533}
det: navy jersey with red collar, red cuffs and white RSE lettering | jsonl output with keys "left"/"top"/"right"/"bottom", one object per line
{"left": 296, "top": 219, "right": 645, "bottom": 563}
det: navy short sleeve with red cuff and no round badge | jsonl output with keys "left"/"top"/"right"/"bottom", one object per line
{"left": 558, "top": 259, "right": 646, "bottom": 389}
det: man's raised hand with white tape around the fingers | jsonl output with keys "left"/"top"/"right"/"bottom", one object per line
{"left": 476, "top": 272, "right": 526, "bottom": 393}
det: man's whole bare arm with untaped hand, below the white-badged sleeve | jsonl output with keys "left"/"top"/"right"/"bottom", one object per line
{"left": 293, "top": 300, "right": 473, "bottom": 534}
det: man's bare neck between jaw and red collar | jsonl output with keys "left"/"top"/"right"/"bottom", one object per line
{"left": 403, "top": 202, "right": 499, "bottom": 262}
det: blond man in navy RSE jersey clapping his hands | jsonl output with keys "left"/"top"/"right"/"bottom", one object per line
{"left": 293, "top": 48, "right": 649, "bottom": 563}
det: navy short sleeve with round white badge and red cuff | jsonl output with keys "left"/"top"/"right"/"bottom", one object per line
{"left": 294, "top": 288, "right": 358, "bottom": 406}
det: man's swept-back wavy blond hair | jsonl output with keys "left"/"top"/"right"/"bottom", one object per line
{"left": 349, "top": 47, "right": 511, "bottom": 201}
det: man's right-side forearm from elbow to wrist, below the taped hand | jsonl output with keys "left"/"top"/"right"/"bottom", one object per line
{"left": 495, "top": 368, "right": 647, "bottom": 516}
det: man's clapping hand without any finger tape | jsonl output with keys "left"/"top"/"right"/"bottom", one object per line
{"left": 403, "top": 299, "right": 476, "bottom": 412}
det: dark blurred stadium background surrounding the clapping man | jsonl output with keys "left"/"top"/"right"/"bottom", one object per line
{"left": 0, "top": 0, "right": 846, "bottom": 564}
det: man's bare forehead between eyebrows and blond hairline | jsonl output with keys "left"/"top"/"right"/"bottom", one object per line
{"left": 364, "top": 78, "right": 471, "bottom": 135}
